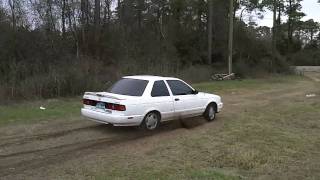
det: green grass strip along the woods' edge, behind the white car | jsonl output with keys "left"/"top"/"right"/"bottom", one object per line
{"left": 0, "top": 76, "right": 302, "bottom": 126}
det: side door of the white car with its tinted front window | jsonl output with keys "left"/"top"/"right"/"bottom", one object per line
{"left": 167, "top": 80, "right": 201, "bottom": 118}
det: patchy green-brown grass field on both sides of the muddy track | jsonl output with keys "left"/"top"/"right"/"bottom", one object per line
{"left": 0, "top": 76, "right": 320, "bottom": 179}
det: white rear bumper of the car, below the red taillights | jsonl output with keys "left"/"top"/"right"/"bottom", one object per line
{"left": 81, "top": 108, "right": 143, "bottom": 126}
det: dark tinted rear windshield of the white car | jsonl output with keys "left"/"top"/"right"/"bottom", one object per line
{"left": 108, "top": 78, "right": 148, "bottom": 96}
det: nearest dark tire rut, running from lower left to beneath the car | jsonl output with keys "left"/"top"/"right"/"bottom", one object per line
{"left": 0, "top": 123, "right": 188, "bottom": 177}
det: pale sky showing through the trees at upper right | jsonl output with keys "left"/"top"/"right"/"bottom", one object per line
{"left": 249, "top": 0, "right": 320, "bottom": 27}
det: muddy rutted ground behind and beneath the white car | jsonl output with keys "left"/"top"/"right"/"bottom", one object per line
{"left": 0, "top": 108, "right": 215, "bottom": 179}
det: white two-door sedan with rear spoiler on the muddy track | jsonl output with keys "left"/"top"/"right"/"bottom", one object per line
{"left": 81, "top": 75, "right": 223, "bottom": 130}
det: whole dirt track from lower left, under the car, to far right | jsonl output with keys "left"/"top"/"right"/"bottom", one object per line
{"left": 0, "top": 74, "right": 318, "bottom": 179}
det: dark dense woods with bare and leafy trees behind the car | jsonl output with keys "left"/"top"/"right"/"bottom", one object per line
{"left": 0, "top": 0, "right": 320, "bottom": 100}
